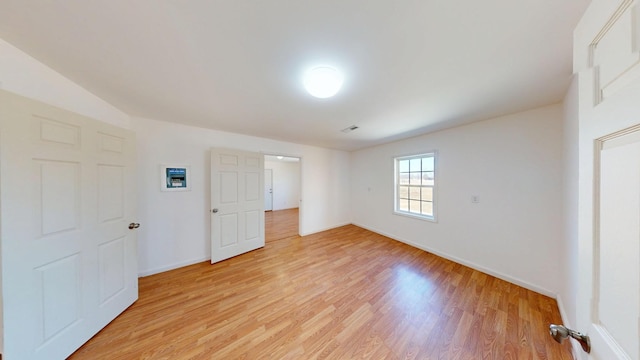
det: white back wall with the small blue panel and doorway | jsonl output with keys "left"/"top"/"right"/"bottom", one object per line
{"left": 132, "top": 118, "right": 350, "bottom": 275}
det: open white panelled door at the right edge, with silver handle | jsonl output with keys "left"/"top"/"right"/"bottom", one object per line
{"left": 574, "top": 0, "right": 640, "bottom": 360}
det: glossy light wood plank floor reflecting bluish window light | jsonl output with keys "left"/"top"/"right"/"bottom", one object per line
{"left": 70, "top": 212, "right": 571, "bottom": 360}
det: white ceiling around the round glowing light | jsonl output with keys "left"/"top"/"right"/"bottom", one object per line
{"left": 0, "top": 0, "right": 589, "bottom": 150}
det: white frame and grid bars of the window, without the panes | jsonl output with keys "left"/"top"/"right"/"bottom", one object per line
{"left": 393, "top": 150, "right": 438, "bottom": 222}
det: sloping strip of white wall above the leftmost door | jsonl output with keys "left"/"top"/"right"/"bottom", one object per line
{"left": 0, "top": 39, "right": 129, "bottom": 128}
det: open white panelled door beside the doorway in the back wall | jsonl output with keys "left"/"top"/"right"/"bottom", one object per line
{"left": 211, "top": 149, "right": 264, "bottom": 264}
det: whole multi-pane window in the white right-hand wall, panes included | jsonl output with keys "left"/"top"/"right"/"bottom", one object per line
{"left": 394, "top": 152, "right": 436, "bottom": 221}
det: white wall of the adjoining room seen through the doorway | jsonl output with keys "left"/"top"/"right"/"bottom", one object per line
{"left": 264, "top": 160, "right": 300, "bottom": 211}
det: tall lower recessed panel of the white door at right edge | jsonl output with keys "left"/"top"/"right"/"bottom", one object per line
{"left": 590, "top": 128, "right": 640, "bottom": 359}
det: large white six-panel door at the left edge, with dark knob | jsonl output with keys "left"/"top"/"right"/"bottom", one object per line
{"left": 0, "top": 91, "right": 138, "bottom": 360}
